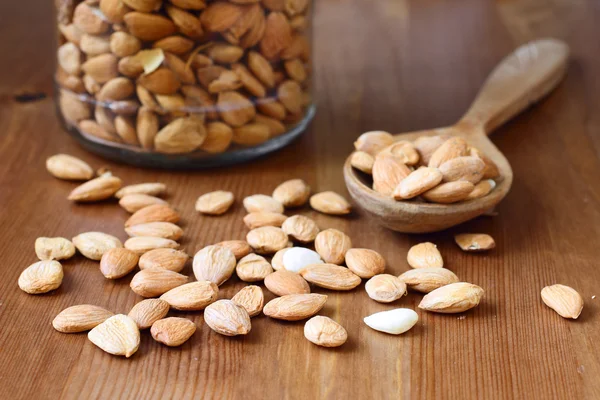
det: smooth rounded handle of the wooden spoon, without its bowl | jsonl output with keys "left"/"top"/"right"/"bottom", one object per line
{"left": 460, "top": 39, "right": 569, "bottom": 134}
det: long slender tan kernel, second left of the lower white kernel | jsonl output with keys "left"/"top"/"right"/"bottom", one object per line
{"left": 263, "top": 293, "right": 327, "bottom": 321}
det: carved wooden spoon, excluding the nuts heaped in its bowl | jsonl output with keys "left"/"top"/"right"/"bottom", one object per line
{"left": 344, "top": 39, "right": 569, "bottom": 233}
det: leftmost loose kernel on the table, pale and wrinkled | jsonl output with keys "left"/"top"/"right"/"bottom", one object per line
{"left": 19, "top": 260, "right": 64, "bottom": 294}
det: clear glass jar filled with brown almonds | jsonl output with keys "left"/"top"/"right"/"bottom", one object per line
{"left": 55, "top": 0, "right": 315, "bottom": 168}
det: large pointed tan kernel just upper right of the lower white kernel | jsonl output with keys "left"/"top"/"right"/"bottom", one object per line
{"left": 419, "top": 282, "right": 483, "bottom": 314}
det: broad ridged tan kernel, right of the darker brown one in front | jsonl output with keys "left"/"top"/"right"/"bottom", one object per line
{"left": 204, "top": 300, "right": 252, "bottom": 336}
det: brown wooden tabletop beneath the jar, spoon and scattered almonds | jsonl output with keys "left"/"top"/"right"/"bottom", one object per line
{"left": 0, "top": 0, "right": 600, "bottom": 399}
